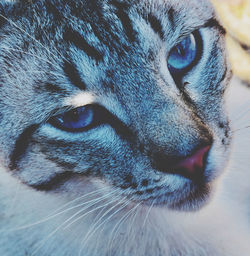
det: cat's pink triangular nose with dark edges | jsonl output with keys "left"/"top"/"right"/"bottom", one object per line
{"left": 174, "top": 146, "right": 211, "bottom": 179}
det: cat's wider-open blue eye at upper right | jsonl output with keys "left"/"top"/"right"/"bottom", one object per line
{"left": 168, "top": 34, "right": 197, "bottom": 74}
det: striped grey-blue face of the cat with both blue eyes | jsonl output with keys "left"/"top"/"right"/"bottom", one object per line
{"left": 0, "top": 0, "right": 230, "bottom": 210}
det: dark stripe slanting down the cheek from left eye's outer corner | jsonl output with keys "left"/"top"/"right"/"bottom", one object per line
{"left": 9, "top": 125, "right": 39, "bottom": 170}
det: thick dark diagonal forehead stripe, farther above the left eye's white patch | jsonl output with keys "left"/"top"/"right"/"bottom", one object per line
{"left": 63, "top": 27, "right": 103, "bottom": 61}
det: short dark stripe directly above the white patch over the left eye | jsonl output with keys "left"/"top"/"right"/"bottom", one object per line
{"left": 63, "top": 61, "right": 86, "bottom": 90}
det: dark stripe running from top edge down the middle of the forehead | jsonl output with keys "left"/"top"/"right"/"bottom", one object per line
{"left": 111, "top": 0, "right": 136, "bottom": 42}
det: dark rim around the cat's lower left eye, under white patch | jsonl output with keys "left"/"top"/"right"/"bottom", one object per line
{"left": 48, "top": 104, "right": 105, "bottom": 133}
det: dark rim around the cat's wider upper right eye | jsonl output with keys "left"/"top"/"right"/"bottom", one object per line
{"left": 167, "top": 30, "right": 203, "bottom": 80}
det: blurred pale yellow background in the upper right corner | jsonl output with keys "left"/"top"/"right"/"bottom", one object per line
{"left": 211, "top": 0, "right": 250, "bottom": 86}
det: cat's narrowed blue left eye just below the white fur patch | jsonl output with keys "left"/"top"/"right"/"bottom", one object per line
{"left": 49, "top": 105, "right": 94, "bottom": 132}
